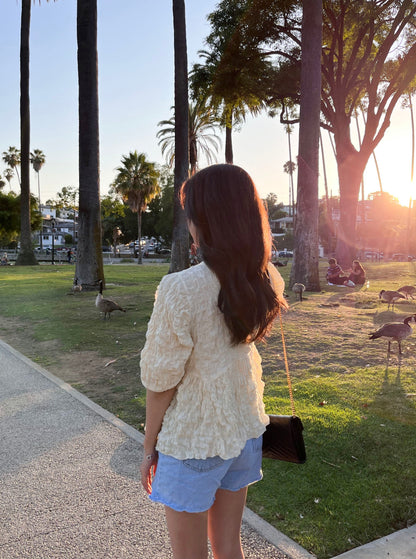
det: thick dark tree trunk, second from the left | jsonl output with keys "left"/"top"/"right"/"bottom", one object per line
{"left": 75, "top": 0, "right": 104, "bottom": 291}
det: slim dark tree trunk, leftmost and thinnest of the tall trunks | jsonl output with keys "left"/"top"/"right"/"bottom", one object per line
{"left": 16, "top": 0, "right": 38, "bottom": 266}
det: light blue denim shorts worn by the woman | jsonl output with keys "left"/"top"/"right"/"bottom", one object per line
{"left": 150, "top": 437, "right": 263, "bottom": 512}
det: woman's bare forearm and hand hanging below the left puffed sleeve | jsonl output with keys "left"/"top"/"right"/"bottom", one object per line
{"left": 140, "top": 387, "right": 176, "bottom": 494}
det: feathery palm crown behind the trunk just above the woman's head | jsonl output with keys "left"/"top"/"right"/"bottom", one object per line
{"left": 157, "top": 100, "right": 221, "bottom": 175}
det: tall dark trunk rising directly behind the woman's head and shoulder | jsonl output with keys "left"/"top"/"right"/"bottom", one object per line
{"left": 169, "top": 0, "right": 189, "bottom": 272}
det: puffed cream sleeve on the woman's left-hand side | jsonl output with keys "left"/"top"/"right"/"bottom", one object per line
{"left": 140, "top": 274, "right": 193, "bottom": 392}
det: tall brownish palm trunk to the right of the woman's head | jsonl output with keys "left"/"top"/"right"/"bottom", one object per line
{"left": 290, "top": 0, "right": 322, "bottom": 291}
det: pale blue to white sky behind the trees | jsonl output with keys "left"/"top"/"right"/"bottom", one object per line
{"left": 0, "top": 0, "right": 416, "bottom": 210}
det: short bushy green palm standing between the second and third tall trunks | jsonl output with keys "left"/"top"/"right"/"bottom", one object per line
{"left": 113, "top": 151, "right": 160, "bottom": 264}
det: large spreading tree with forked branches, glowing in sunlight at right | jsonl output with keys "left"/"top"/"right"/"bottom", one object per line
{"left": 204, "top": 0, "right": 416, "bottom": 262}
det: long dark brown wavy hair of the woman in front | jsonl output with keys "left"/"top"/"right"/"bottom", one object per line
{"left": 181, "top": 164, "right": 284, "bottom": 344}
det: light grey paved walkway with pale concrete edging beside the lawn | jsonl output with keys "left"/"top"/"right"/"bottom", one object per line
{"left": 0, "top": 340, "right": 416, "bottom": 559}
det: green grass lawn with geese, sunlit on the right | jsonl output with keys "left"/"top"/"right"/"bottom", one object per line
{"left": 0, "top": 261, "right": 416, "bottom": 559}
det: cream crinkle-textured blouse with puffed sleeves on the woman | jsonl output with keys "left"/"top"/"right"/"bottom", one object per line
{"left": 140, "top": 263, "right": 284, "bottom": 460}
